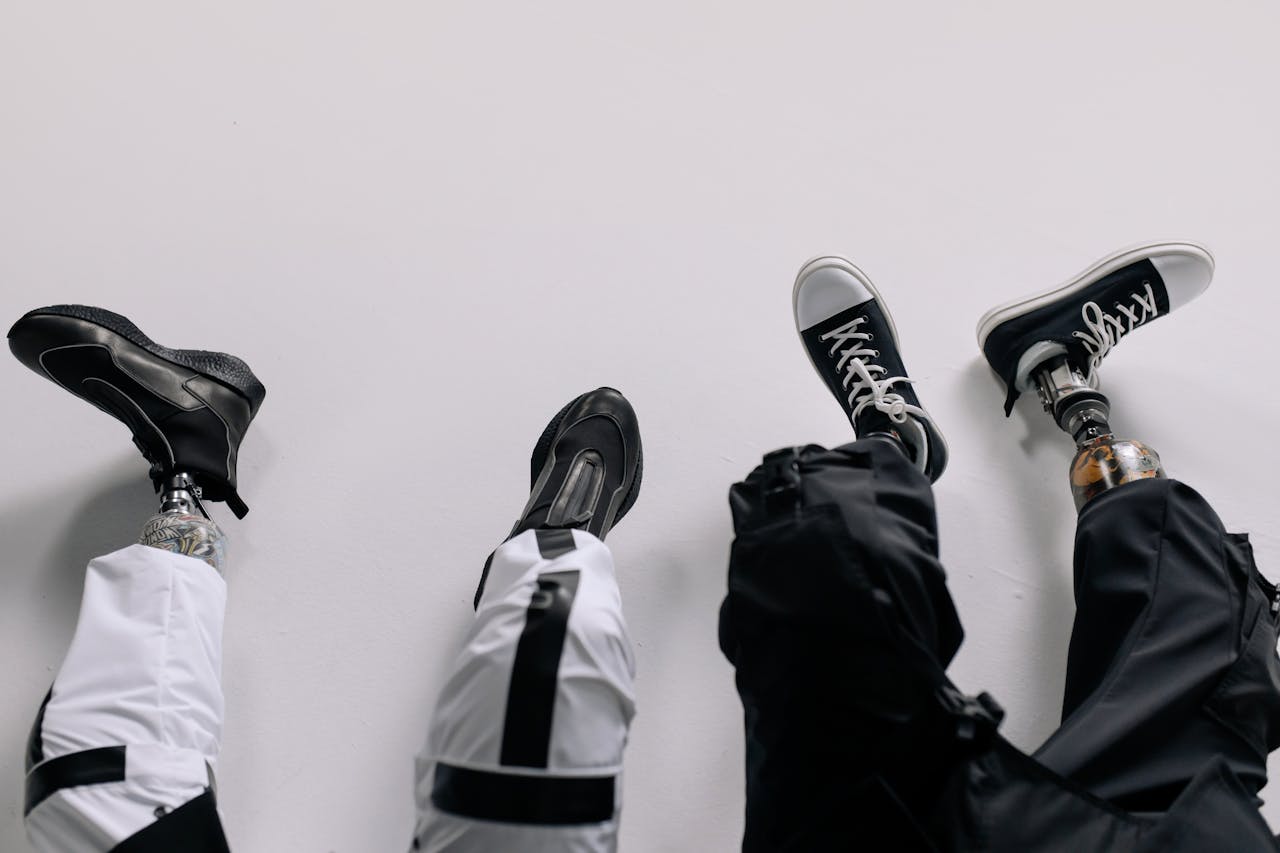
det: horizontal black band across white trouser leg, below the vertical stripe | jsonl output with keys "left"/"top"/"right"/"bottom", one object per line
{"left": 431, "top": 763, "right": 614, "bottom": 825}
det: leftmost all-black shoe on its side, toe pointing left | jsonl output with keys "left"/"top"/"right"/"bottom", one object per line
{"left": 9, "top": 305, "right": 266, "bottom": 517}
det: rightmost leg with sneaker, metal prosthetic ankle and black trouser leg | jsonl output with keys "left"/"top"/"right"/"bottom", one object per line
{"left": 978, "top": 243, "right": 1280, "bottom": 829}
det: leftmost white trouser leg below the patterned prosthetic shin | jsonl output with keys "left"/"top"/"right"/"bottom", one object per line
{"left": 26, "top": 544, "right": 227, "bottom": 853}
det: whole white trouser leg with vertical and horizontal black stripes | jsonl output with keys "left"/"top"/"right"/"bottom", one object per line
{"left": 413, "top": 530, "right": 635, "bottom": 853}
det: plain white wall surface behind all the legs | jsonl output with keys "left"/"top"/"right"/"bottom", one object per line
{"left": 0, "top": 0, "right": 1280, "bottom": 853}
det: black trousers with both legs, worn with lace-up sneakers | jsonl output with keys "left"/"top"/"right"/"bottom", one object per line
{"left": 719, "top": 439, "right": 1280, "bottom": 852}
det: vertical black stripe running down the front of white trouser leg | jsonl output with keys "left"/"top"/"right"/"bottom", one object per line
{"left": 500, "top": 571, "right": 579, "bottom": 767}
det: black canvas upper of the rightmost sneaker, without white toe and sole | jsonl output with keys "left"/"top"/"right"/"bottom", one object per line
{"left": 982, "top": 259, "right": 1169, "bottom": 415}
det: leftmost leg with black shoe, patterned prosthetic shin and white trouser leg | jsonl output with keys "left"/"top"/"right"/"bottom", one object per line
{"left": 9, "top": 306, "right": 265, "bottom": 853}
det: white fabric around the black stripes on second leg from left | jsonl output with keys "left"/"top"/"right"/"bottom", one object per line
{"left": 413, "top": 530, "right": 635, "bottom": 853}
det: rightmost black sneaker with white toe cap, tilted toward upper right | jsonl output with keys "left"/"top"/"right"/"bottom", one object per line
{"left": 978, "top": 242, "right": 1213, "bottom": 415}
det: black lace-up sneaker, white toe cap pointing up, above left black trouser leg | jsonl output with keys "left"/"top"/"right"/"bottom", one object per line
{"left": 791, "top": 256, "right": 947, "bottom": 480}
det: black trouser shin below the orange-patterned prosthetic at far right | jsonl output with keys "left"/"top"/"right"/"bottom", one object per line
{"left": 1036, "top": 480, "right": 1280, "bottom": 812}
